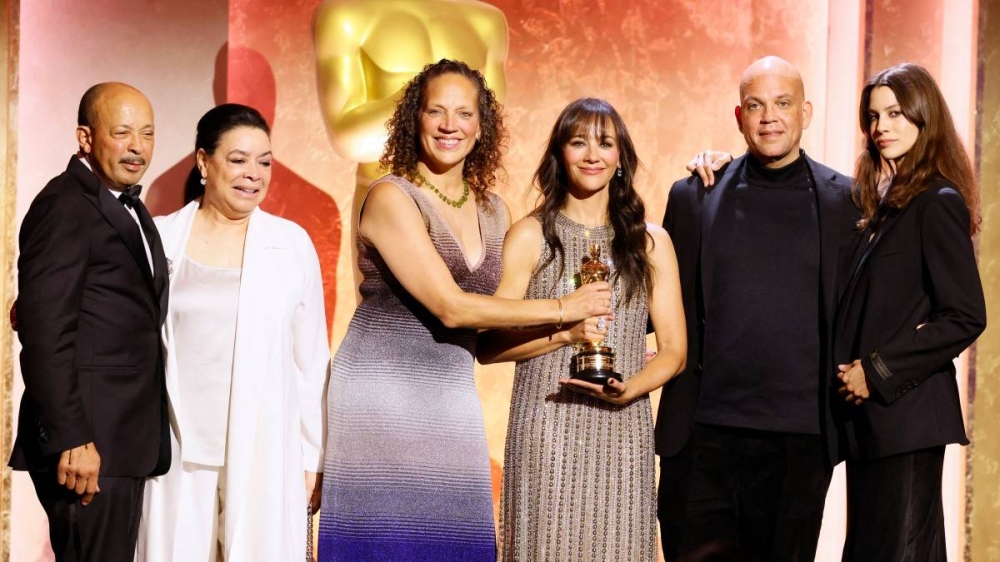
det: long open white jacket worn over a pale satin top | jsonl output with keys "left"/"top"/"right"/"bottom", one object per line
{"left": 136, "top": 201, "right": 330, "bottom": 562}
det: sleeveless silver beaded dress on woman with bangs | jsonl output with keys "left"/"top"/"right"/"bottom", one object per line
{"left": 500, "top": 215, "right": 656, "bottom": 562}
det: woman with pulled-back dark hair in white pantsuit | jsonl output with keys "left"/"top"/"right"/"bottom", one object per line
{"left": 136, "top": 104, "right": 330, "bottom": 562}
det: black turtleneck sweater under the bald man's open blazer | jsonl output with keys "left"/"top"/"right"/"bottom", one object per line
{"left": 697, "top": 150, "right": 821, "bottom": 434}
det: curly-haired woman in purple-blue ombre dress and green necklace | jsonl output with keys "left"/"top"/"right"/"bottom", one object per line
{"left": 319, "top": 60, "right": 611, "bottom": 562}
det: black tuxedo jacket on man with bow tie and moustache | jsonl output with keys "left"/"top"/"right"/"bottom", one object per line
{"left": 10, "top": 157, "right": 170, "bottom": 477}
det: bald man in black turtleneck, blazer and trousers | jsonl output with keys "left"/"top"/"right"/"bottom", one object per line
{"left": 656, "top": 57, "right": 857, "bottom": 562}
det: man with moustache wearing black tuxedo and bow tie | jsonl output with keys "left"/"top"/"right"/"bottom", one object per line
{"left": 10, "top": 83, "right": 170, "bottom": 562}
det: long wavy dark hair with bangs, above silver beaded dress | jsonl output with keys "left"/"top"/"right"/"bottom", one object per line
{"left": 533, "top": 98, "right": 653, "bottom": 302}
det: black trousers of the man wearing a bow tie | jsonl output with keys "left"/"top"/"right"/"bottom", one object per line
{"left": 29, "top": 470, "right": 146, "bottom": 562}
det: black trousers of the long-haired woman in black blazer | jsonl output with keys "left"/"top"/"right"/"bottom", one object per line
{"left": 843, "top": 447, "right": 948, "bottom": 562}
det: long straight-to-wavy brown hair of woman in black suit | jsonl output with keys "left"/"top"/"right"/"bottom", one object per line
{"left": 851, "top": 63, "right": 981, "bottom": 236}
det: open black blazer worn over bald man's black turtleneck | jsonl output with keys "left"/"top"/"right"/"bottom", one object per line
{"left": 655, "top": 153, "right": 859, "bottom": 462}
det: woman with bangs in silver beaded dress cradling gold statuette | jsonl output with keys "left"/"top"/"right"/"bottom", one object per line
{"left": 479, "top": 99, "right": 687, "bottom": 562}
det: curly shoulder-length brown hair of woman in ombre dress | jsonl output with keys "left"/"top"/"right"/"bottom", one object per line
{"left": 379, "top": 59, "right": 507, "bottom": 203}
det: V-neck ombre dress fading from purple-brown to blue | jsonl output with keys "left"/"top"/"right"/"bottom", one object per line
{"left": 319, "top": 176, "right": 506, "bottom": 562}
